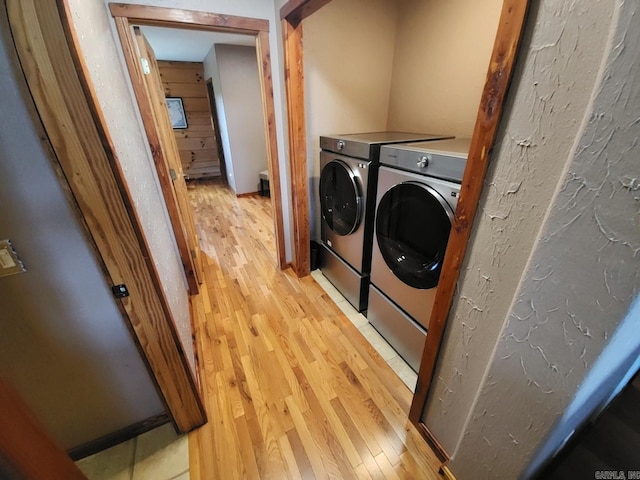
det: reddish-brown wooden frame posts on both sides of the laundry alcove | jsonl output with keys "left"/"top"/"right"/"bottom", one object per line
{"left": 280, "top": 0, "right": 529, "bottom": 461}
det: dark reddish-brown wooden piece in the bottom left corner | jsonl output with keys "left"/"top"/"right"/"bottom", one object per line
{"left": 0, "top": 379, "right": 86, "bottom": 480}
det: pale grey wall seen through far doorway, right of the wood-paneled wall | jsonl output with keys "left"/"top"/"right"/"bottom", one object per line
{"left": 214, "top": 45, "right": 267, "bottom": 195}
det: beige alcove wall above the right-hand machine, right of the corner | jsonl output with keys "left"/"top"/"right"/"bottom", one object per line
{"left": 387, "top": 0, "right": 502, "bottom": 137}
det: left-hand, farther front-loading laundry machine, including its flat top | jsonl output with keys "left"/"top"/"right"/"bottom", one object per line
{"left": 319, "top": 132, "right": 451, "bottom": 312}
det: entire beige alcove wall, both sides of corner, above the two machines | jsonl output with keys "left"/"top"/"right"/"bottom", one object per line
{"left": 303, "top": 0, "right": 502, "bottom": 238}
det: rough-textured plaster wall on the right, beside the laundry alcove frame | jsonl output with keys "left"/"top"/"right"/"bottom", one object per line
{"left": 423, "top": 1, "right": 640, "bottom": 480}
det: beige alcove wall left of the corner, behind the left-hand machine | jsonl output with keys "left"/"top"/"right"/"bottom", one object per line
{"left": 303, "top": 0, "right": 397, "bottom": 238}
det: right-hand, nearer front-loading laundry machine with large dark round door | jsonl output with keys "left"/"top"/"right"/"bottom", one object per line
{"left": 367, "top": 139, "right": 470, "bottom": 371}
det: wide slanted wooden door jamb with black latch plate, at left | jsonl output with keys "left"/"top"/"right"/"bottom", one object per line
{"left": 7, "top": 0, "right": 206, "bottom": 432}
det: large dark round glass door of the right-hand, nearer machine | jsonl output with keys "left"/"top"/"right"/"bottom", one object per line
{"left": 376, "top": 182, "right": 453, "bottom": 289}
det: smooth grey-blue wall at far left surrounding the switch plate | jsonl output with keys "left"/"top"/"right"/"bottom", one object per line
{"left": 0, "top": 12, "right": 164, "bottom": 448}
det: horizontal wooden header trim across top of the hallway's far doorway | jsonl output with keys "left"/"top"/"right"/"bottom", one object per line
{"left": 109, "top": 3, "right": 269, "bottom": 35}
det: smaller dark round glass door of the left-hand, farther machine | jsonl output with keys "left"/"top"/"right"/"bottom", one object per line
{"left": 320, "top": 160, "right": 363, "bottom": 236}
